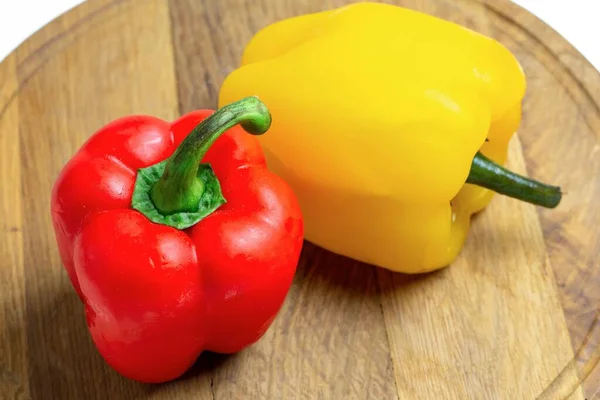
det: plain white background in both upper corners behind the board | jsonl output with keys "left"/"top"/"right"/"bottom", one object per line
{"left": 0, "top": 0, "right": 600, "bottom": 70}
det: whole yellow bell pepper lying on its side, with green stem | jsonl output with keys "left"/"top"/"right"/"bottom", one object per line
{"left": 219, "top": 3, "right": 561, "bottom": 273}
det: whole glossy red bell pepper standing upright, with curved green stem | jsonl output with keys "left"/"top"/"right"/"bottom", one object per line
{"left": 51, "top": 97, "right": 304, "bottom": 383}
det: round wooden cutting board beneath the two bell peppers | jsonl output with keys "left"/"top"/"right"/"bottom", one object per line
{"left": 0, "top": 0, "right": 600, "bottom": 400}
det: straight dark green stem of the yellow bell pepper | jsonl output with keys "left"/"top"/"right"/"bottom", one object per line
{"left": 467, "top": 152, "right": 562, "bottom": 208}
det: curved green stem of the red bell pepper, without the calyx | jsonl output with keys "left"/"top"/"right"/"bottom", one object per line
{"left": 150, "top": 97, "right": 271, "bottom": 215}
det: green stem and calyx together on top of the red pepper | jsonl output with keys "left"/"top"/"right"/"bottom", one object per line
{"left": 132, "top": 97, "right": 271, "bottom": 229}
